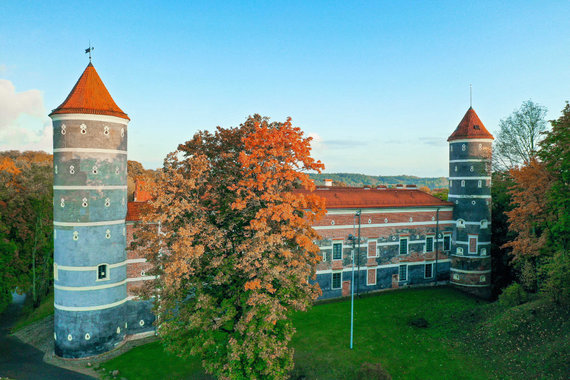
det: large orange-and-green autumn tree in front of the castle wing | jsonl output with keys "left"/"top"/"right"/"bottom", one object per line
{"left": 135, "top": 115, "right": 325, "bottom": 379}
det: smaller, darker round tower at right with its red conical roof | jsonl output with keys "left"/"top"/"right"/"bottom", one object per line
{"left": 447, "top": 107, "right": 493, "bottom": 297}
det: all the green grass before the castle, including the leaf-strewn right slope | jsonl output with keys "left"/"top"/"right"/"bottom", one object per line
{"left": 102, "top": 288, "right": 570, "bottom": 380}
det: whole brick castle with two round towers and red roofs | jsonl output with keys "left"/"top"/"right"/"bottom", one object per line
{"left": 50, "top": 63, "right": 493, "bottom": 358}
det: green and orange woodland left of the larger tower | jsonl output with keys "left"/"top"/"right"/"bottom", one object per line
{"left": 0, "top": 151, "right": 53, "bottom": 306}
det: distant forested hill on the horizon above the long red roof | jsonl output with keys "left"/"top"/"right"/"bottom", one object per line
{"left": 310, "top": 173, "right": 448, "bottom": 190}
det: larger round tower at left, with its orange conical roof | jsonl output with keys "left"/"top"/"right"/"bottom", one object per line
{"left": 49, "top": 63, "right": 130, "bottom": 358}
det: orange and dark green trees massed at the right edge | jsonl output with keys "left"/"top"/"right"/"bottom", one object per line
{"left": 503, "top": 104, "right": 570, "bottom": 302}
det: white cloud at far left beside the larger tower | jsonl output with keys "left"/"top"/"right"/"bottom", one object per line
{"left": 0, "top": 79, "right": 53, "bottom": 152}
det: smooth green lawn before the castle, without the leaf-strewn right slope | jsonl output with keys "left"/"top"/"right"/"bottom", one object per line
{"left": 102, "top": 288, "right": 492, "bottom": 380}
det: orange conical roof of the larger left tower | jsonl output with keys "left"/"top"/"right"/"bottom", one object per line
{"left": 50, "top": 62, "right": 130, "bottom": 120}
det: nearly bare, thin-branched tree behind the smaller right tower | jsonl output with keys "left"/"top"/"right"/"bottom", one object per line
{"left": 493, "top": 100, "right": 547, "bottom": 170}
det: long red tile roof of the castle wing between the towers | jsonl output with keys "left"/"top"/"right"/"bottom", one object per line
{"left": 298, "top": 186, "right": 453, "bottom": 209}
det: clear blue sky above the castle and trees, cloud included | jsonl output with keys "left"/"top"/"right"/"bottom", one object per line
{"left": 0, "top": 0, "right": 570, "bottom": 177}
